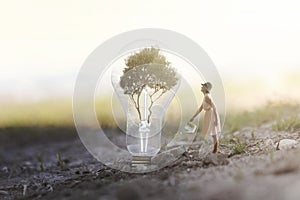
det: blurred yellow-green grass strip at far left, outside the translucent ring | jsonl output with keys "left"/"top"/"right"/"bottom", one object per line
{"left": 0, "top": 99, "right": 74, "bottom": 127}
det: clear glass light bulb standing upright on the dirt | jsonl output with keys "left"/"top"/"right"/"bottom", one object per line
{"left": 111, "top": 64, "right": 180, "bottom": 160}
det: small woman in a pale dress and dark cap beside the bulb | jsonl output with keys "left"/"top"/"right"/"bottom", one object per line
{"left": 190, "top": 82, "right": 221, "bottom": 153}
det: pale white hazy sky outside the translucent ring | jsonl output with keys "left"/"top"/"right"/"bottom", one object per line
{"left": 0, "top": 0, "right": 300, "bottom": 109}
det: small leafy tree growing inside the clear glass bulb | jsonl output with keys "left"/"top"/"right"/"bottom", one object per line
{"left": 120, "top": 47, "right": 179, "bottom": 123}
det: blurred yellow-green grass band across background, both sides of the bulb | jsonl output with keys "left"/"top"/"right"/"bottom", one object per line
{"left": 0, "top": 99, "right": 300, "bottom": 133}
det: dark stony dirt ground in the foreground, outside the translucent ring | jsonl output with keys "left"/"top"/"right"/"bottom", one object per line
{"left": 0, "top": 124, "right": 300, "bottom": 200}
